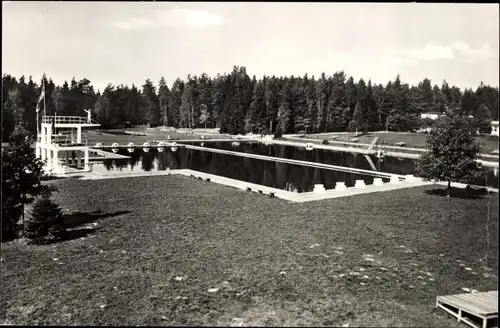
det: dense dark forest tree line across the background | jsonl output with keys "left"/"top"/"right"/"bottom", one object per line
{"left": 2, "top": 66, "right": 499, "bottom": 140}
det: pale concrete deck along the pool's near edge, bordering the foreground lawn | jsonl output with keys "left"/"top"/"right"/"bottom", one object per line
{"left": 68, "top": 169, "right": 442, "bottom": 203}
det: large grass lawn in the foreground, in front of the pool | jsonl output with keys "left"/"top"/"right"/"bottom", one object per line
{"left": 0, "top": 176, "right": 498, "bottom": 327}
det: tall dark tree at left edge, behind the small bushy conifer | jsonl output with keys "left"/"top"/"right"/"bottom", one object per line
{"left": 2, "top": 123, "right": 55, "bottom": 240}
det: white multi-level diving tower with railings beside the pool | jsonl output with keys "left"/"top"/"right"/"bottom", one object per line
{"left": 36, "top": 114, "right": 101, "bottom": 175}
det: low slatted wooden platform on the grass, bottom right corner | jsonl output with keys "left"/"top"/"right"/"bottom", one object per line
{"left": 436, "top": 290, "right": 498, "bottom": 328}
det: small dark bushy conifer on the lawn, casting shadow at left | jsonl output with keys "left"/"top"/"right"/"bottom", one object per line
{"left": 24, "top": 197, "right": 64, "bottom": 243}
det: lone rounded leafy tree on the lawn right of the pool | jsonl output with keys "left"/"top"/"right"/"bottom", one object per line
{"left": 417, "top": 111, "right": 480, "bottom": 195}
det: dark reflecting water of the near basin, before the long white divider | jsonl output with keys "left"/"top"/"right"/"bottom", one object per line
{"left": 92, "top": 148, "right": 389, "bottom": 192}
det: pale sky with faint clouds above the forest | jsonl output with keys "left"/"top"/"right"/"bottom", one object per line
{"left": 2, "top": 1, "right": 500, "bottom": 90}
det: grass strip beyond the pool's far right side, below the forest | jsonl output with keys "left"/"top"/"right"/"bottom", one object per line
{"left": 296, "top": 132, "right": 499, "bottom": 153}
